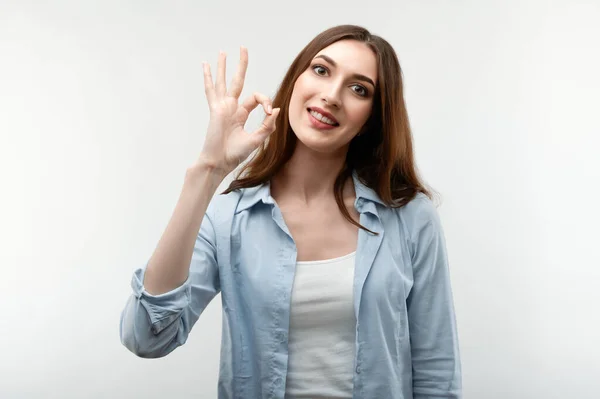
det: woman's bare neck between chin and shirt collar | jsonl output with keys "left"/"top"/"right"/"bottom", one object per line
{"left": 271, "top": 141, "right": 354, "bottom": 205}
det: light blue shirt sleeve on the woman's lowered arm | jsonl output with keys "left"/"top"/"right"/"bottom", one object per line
{"left": 407, "top": 200, "right": 462, "bottom": 399}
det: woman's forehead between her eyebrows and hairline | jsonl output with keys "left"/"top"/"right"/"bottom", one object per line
{"left": 316, "top": 40, "right": 377, "bottom": 82}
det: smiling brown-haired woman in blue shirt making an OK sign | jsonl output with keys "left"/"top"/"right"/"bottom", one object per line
{"left": 120, "top": 25, "right": 461, "bottom": 399}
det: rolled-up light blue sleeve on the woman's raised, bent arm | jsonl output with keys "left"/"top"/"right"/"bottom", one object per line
{"left": 119, "top": 212, "right": 220, "bottom": 358}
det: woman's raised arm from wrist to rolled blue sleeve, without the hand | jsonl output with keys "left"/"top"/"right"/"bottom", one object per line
{"left": 119, "top": 162, "right": 221, "bottom": 358}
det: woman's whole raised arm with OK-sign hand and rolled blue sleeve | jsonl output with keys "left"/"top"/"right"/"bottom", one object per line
{"left": 120, "top": 47, "right": 280, "bottom": 357}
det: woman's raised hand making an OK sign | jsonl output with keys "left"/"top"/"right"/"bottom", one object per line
{"left": 200, "top": 47, "right": 280, "bottom": 174}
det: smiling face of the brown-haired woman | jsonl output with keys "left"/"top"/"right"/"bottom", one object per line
{"left": 288, "top": 40, "right": 377, "bottom": 153}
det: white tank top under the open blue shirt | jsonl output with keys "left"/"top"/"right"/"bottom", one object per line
{"left": 285, "top": 251, "right": 356, "bottom": 399}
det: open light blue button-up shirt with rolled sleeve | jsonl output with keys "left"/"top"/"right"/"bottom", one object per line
{"left": 120, "top": 173, "right": 462, "bottom": 399}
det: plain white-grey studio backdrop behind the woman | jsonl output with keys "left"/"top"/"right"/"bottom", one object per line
{"left": 0, "top": 0, "right": 600, "bottom": 399}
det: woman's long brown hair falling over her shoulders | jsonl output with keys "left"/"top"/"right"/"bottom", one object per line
{"left": 222, "top": 25, "right": 432, "bottom": 231}
